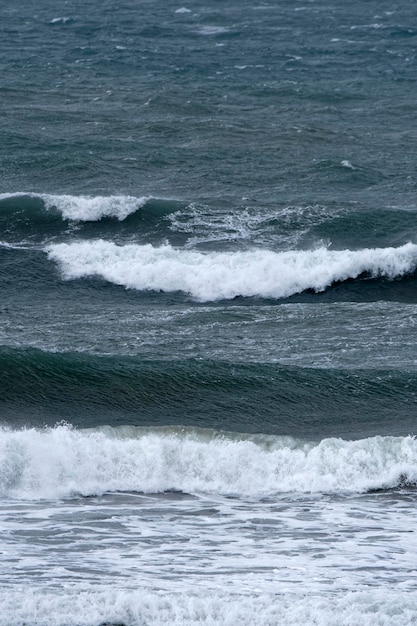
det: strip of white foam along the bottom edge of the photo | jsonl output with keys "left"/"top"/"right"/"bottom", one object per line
{"left": 0, "top": 588, "right": 417, "bottom": 626}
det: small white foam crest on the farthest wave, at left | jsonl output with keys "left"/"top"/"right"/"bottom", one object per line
{"left": 0, "top": 192, "right": 149, "bottom": 222}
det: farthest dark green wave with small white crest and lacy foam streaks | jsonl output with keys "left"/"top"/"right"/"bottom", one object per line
{"left": 0, "top": 192, "right": 415, "bottom": 250}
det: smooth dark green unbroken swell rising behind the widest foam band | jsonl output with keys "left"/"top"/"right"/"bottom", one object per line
{"left": 0, "top": 348, "right": 417, "bottom": 439}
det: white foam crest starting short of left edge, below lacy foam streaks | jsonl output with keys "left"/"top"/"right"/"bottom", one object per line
{"left": 46, "top": 240, "right": 417, "bottom": 301}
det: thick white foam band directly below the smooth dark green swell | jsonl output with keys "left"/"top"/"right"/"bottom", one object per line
{"left": 0, "top": 425, "right": 417, "bottom": 499}
